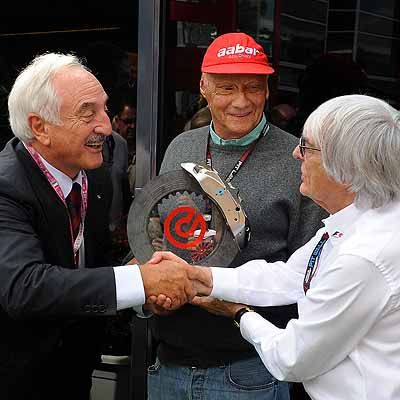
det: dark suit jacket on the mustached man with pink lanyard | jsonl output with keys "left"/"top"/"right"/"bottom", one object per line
{"left": 0, "top": 139, "right": 116, "bottom": 400}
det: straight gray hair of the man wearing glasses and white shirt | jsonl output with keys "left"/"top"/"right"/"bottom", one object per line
{"left": 303, "top": 95, "right": 400, "bottom": 208}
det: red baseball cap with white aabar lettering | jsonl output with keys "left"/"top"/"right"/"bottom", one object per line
{"left": 201, "top": 33, "right": 274, "bottom": 75}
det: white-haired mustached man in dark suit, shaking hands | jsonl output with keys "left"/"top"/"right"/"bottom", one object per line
{"left": 0, "top": 53, "right": 198, "bottom": 400}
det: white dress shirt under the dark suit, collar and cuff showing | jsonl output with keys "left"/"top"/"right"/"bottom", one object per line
{"left": 39, "top": 154, "right": 146, "bottom": 310}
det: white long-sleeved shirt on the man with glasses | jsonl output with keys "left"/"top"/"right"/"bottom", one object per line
{"left": 211, "top": 202, "right": 400, "bottom": 400}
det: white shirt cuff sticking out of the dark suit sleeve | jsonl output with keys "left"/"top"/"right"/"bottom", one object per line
{"left": 113, "top": 265, "right": 146, "bottom": 311}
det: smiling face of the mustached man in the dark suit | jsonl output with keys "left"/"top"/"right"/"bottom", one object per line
{"left": 41, "top": 67, "right": 111, "bottom": 178}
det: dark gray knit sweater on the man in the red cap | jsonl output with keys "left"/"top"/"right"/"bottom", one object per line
{"left": 153, "top": 125, "right": 327, "bottom": 366}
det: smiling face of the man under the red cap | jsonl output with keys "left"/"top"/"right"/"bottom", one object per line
{"left": 200, "top": 74, "right": 268, "bottom": 139}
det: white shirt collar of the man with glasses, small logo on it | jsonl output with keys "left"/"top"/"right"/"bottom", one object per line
{"left": 322, "top": 204, "right": 363, "bottom": 244}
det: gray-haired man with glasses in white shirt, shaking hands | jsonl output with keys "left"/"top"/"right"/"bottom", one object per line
{"left": 152, "top": 95, "right": 400, "bottom": 400}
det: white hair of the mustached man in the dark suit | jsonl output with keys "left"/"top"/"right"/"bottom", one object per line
{"left": 8, "top": 53, "right": 87, "bottom": 142}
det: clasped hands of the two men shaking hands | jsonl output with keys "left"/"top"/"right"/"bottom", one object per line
{"left": 139, "top": 251, "right": 212, "bottom": 311}
